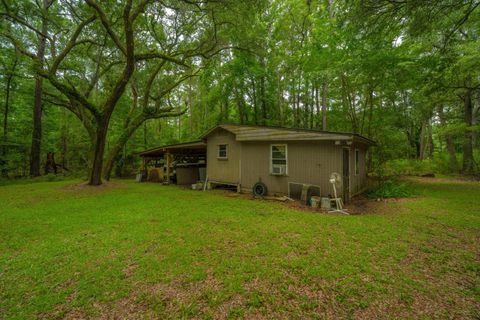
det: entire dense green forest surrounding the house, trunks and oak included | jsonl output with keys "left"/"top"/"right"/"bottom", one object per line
{"left": 0, "top": 0, "right": 480, "bottom": 185}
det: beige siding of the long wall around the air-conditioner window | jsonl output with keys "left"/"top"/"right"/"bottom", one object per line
{"left": 241, "top": 141, "right": 342, "bottom": 196}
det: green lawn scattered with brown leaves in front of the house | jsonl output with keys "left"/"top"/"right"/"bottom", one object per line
{"left": 0, "top": 179, "right": 480, "bottom": 319}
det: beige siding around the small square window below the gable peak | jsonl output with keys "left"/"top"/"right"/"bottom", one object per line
{"left": 207, "top": 129, "right": 242, "bottom": 184}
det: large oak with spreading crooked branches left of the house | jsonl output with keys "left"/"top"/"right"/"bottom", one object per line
{"left": 2, "top": 0, "right": 248, "bottom": 185}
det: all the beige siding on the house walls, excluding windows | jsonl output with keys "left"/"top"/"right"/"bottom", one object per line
{"left": 207, "top": 128, "right": 366, "bottom": 196}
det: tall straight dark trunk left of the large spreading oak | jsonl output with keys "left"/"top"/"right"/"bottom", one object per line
{"left": 30, "top": 0, "right": 50, "bottom": 177}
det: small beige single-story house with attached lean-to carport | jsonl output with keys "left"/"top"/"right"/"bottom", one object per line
{"left": 140, "top": 124, "right": 374, "bottom": 201}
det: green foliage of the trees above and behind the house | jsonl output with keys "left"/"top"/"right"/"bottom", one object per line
{"left": 0, "top": 0, "right": 480, "bottom": 178}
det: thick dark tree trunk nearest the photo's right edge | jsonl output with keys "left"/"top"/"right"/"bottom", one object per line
{"left": 462, "top": 89, "right": 475, "bottom": 174}
